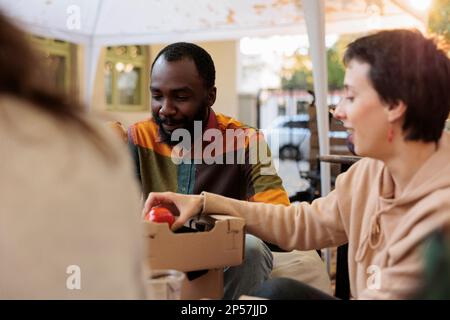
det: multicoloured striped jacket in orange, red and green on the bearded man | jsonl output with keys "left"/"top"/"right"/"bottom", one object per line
{"left": 128, "top": 110, "right": 289, "bottom": 205}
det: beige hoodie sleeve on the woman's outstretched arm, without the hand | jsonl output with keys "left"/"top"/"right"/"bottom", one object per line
{"left": 203, "top": 191, "right": 347, "bottom": 251}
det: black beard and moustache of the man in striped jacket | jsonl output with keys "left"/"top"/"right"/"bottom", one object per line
{"left": 152, "top": 102, "right": 209, "bottom": 146}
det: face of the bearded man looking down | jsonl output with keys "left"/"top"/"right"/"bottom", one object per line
{"left": 150, "top": 56, "right": 216, "bottom": 143}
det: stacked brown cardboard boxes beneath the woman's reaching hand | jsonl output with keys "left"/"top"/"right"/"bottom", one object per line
{"left": 144, "top": 215, "right": 245, "bottom": 299}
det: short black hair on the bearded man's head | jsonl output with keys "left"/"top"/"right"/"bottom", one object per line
{"left": 151, "top": 42, "right": 216, "bottom": 89}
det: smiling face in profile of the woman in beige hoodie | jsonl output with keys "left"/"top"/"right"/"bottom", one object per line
{"left": 334, "top": 60, "right": 389, "bottom": 160}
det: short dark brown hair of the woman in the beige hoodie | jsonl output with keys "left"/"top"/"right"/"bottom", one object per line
{"left": 344, "top": 30, "right": 450, "bottom": 142}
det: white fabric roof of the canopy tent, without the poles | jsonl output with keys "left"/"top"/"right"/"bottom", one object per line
{"left": 0, "top": 0, "right": 420, "bottom": 46}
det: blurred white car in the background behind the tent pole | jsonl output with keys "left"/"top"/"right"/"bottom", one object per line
{"left": 262, "top": 114, "right": 348, "bottom": 161}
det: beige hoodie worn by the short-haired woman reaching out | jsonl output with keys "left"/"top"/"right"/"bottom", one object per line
{"left": 204, "top": 133, "right": 450, "bottom": 299}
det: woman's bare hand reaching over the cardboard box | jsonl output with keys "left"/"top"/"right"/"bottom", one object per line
{"left": 142, "top": 192, "right": 203, "bottom": 230}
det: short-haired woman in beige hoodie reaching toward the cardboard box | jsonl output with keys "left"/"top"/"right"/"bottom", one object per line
{"left": 144, "top": 30, "right": 450, "bottom": 299}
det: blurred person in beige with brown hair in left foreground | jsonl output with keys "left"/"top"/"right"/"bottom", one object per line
{"left": 0, "top": 13, "right": 144, "bottom": 299}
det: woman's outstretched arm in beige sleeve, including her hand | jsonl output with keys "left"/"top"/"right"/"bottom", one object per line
{"left": 143, "top": 192, "right": 348, "bottom": 250}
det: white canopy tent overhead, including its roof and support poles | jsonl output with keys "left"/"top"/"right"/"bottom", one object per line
{"left": 0, "top": 0, "right": 425, "bottom": 195}
